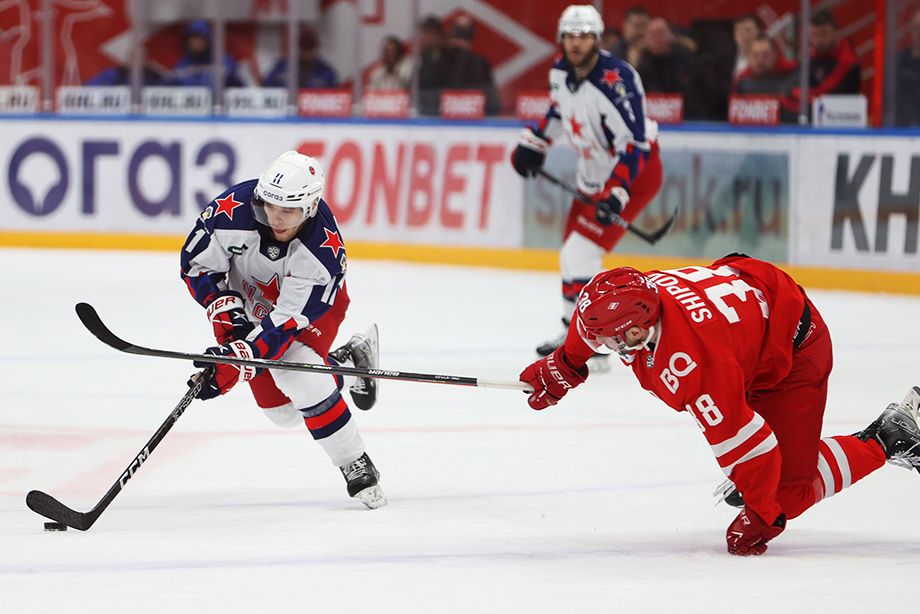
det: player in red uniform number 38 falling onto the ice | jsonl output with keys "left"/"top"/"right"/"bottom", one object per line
{"left": 521, "top": 254, "right": 920, "bottom": 555}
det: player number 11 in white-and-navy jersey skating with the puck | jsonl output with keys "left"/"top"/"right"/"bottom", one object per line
{"left": 182, "top": 151, "right": 386, "bottom": 509}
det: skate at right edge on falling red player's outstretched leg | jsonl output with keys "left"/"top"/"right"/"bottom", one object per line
{"left": 856, "top": 386, "right": 920, "bottom": 471}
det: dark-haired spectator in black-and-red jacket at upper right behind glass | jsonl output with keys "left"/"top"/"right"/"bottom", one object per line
{"left": 783, "top": 10, "right": 860, "bottom": 112}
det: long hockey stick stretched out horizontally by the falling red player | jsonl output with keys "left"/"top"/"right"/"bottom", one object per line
{"left": 76, "top": 303, "right": 532, "bottom": 392}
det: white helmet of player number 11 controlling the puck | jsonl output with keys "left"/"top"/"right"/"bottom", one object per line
{"left": 252, "top": 151, "right": 326, "bottom": 226}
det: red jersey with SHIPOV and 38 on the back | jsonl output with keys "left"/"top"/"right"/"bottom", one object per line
{"left": 566, "top": 256, "right": 820, "bottom": 521}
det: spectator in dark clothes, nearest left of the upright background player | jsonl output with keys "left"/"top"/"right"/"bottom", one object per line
{"left": 444, "top": 15, "right": 499, "bottom": 115}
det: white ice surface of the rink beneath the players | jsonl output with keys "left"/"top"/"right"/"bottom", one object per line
{"left": 0, "top": 250, "right": 920, "bottom": 614}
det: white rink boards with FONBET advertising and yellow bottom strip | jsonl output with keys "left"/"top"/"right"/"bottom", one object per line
{"left": 0, "top": 118, "right": 920, "bottom": 294}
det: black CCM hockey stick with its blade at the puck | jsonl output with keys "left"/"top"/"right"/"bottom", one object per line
{"left": 26, "top": 367, "right": 211, "bottom": 531}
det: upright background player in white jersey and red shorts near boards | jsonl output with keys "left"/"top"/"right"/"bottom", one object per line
{"left": 511, "top": 5, "right": 662, "bottom": 368}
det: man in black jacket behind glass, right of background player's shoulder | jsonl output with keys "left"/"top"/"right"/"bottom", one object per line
{"left": 636, "top": 17, "right": 705, "bottom": 120}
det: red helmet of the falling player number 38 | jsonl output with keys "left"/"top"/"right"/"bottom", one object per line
{"left": 575, "top": 267, "right": 661, "bottom": 350}
